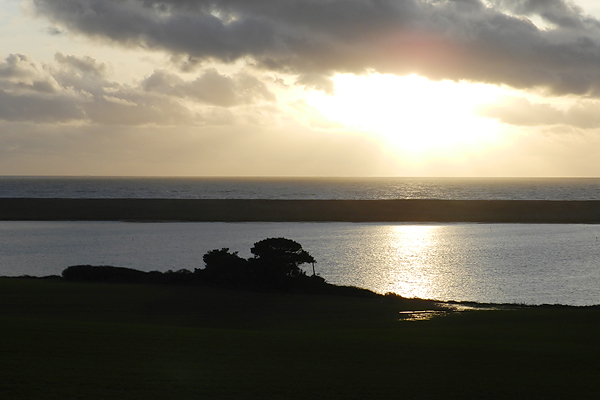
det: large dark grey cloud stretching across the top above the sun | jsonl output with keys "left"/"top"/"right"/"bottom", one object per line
{"left": 34, "top": 0, "right": 600, "bottom": 95}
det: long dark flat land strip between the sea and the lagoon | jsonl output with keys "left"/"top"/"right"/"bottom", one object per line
{"left": 0, "top": 198, "right": 600, "bottom": 224}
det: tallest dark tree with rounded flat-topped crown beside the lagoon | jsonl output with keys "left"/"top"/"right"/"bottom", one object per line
{"left": 249, "top": 238, "right": 315, "bottom": 278}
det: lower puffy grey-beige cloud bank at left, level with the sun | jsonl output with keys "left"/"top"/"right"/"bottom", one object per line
{"left": 0, "top": 53, "right": 275, "bottom": 125}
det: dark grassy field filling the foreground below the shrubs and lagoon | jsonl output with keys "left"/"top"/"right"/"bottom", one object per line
{"left": 0, "top": 278, "right": 600, "bottom": 399}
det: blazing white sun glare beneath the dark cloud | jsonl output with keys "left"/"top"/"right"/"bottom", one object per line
{"left": 307, "top": 74, "right": 504, "bottom": 155}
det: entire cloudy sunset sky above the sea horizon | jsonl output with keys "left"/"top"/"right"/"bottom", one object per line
{"left": 0, "top": 0, "right": 600, "bottom": 177}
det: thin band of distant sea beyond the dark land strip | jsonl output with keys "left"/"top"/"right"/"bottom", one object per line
{"left": 0, "top": 176, "right": 600, "bottom": 200}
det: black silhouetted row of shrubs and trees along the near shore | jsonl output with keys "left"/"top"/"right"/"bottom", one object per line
{"left": 62, "top": 238, "right": 377, "bottom": 296}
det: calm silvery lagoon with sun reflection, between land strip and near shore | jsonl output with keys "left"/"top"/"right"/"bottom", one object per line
{"left": 0, "top": 222, "right": 600, "bottom": 305}
